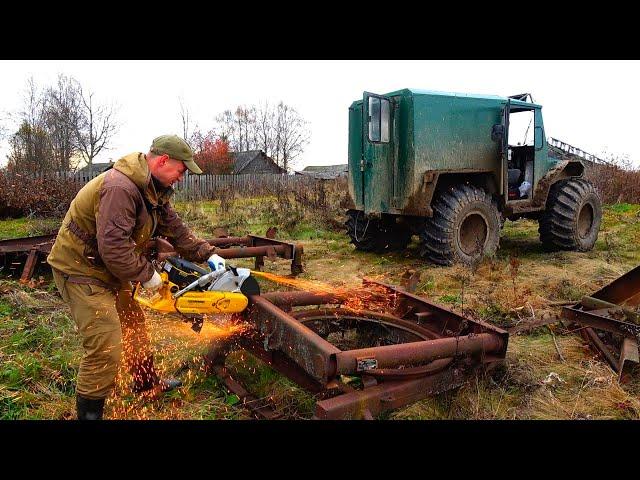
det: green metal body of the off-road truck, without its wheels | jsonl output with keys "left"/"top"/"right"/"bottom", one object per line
{"left": 348, "top": 89, "right": 557, "bottom": 214}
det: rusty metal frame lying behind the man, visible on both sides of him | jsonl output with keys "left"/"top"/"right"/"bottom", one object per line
{"left": 0, "top": 228, "right": 304, "bottom": 283}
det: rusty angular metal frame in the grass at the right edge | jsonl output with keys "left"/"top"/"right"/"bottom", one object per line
{"left": 562, "top": 266, "right": 640, "bottom": 380}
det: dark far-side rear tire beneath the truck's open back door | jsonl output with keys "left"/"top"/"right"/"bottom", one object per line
{"left": 345, "top": 210, "right": 411, "bottom": 253}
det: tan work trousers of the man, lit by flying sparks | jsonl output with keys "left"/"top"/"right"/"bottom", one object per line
{"left": 53, "top": 270, "right": 157, "bottom": 399}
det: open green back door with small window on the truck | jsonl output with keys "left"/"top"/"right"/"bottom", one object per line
{"left": 360, "top": 92, "right": 398, "bottom": 213}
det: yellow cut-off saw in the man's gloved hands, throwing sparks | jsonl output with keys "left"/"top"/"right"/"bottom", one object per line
{"left": 133, "top": 238, "right": 260, "bottom": 332}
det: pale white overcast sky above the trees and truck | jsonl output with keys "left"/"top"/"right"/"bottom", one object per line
{"left": 0, "top": 60, "right": 640, "bottom": 169}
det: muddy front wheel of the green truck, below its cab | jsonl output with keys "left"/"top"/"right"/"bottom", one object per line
{"left": 538, "top": 178, "right": 602, "bottom": 252}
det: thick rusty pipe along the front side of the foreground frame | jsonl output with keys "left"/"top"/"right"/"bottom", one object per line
{"left": 336, "top": 333, "right": 503, "bottom": 375}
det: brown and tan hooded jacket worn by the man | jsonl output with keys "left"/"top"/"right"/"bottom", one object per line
{"left": 47, "top": 153, "right": 215, "bottom": 286}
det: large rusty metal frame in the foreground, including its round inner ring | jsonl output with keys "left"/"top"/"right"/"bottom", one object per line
{"left": 205, "top": 280, "right": 508, "bottom": 419}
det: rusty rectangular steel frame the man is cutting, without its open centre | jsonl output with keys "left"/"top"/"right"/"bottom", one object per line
{"left": 207, "top": 280, "right": 508, "bottom": 419}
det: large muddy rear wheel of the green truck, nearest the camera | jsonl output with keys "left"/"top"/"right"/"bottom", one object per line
{"left": 420, "top": 185, "right": 500, "bottom": 265}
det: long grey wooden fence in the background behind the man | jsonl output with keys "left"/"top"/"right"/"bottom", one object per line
{"left": 22, "top": 172, "right": 332, "bottom": 200}
